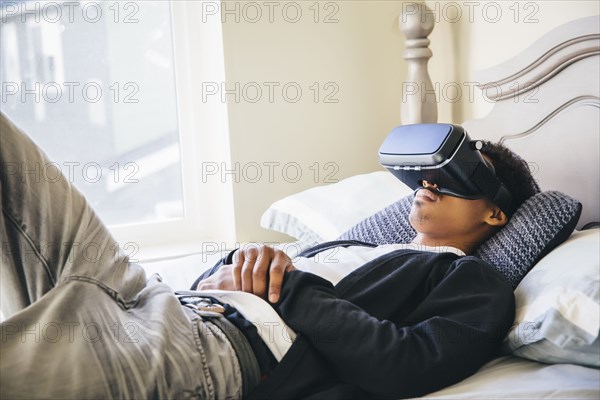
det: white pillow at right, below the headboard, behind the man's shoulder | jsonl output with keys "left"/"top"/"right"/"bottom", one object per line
{"left": 504, "top": 229, "right": 600, "bottom": 367}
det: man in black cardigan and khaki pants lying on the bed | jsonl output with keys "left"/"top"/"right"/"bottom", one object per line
{"left": 0, "top": 114, "right": 538, "bottom": 398}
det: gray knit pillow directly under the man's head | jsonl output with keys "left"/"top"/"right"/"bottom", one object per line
{"left": 339, "top": 191, "right": 581, "bottom": 288}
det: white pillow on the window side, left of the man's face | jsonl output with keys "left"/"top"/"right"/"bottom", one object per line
{"left": 260, "top": 171, "right": 412, "bottom": 244}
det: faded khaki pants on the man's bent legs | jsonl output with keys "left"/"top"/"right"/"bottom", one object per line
{"left": 0, "top": 114, "right": 242, "bottom": 399}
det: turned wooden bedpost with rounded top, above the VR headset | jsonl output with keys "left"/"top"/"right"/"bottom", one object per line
{"left": 399, "top": 2, "right": 437, "bottom": 125}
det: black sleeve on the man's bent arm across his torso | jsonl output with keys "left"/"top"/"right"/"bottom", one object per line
{"left": 276, "top": 258, "right": 514, "bottom": 397}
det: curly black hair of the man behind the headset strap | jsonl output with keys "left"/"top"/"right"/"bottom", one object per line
{"left": 480, "top": 140, "right": 540, "bottom": 217}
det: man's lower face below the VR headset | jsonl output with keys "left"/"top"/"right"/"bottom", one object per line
{"left": 409, "top": 182, "right": 502, "bottom": 242}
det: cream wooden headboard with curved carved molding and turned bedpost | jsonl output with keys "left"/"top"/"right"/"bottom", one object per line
{"left": 401, "top": 7, "right": 600, "bottom": 229}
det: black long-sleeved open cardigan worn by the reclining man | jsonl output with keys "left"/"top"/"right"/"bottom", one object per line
{"left": 251, "top": 242, "right": 515, "bottom": 399}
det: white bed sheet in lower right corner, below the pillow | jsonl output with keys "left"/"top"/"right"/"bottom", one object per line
{"left": 425, "top": 356, "right": 600, "bottom": 400}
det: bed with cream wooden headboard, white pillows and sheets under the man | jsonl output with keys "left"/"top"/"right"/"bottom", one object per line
{"left": 145, "top": 7, "right": 600, "bottom": 399}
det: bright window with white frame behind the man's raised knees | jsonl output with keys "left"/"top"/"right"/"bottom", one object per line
{"left": 0, "top": 0, "right": 232, "bottom": 258}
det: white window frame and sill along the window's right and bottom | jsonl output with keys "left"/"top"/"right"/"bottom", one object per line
{"left": 108, "top": 0, "right": 235, "bottom": 262}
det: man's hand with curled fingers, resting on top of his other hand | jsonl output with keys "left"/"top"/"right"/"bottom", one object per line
{"left": 232, "top": 245, "right": 296, "bottom": 303}
